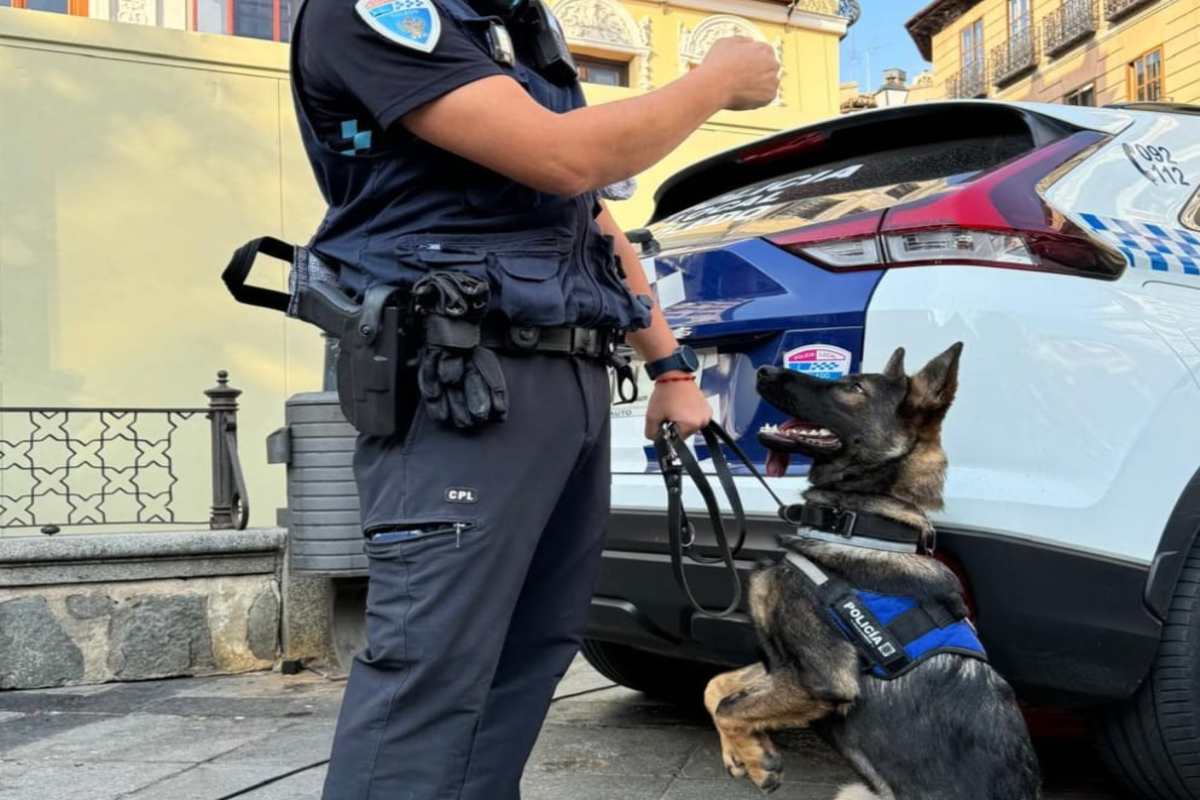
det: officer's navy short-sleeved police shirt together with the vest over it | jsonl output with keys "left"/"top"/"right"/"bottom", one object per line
{"left": 292, "top": 0, "right": 649, "bottom": 330}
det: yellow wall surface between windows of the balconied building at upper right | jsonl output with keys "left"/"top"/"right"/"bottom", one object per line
{"left": 932, "top": 0, "right": 1200, "bottom": 106}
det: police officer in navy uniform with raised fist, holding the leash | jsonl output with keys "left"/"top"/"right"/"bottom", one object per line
{"left": 292, "top": 0, "right": 779, "bottom": 800}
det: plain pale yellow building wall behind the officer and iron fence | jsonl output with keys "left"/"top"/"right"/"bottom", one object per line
{"left": 0, "top": 0, "right": 838, "bottom": 532}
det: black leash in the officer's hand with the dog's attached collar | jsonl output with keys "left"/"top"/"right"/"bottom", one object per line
{"left": 654, "top": 422, "right": 934, "bottom": 616}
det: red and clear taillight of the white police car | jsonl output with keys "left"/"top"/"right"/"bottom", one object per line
{"left": 769, "top": 131, "right": 1124, "bottom": 278}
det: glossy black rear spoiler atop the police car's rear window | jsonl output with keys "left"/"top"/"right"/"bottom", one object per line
{"left": 650, "top": 102, "right": 1079, "bottom": 224}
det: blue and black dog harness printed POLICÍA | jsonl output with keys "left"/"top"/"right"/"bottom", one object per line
{"left": 784, "top": 551, "right": 988, "bottom": 680}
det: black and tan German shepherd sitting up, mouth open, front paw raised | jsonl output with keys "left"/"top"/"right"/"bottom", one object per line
{"left": 704, "top": 343, "right": 1040, "bottom": 800}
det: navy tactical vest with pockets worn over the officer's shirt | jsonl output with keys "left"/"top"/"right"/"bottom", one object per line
{"left": 292, "top": 0, "right": 650, "bottom": 330}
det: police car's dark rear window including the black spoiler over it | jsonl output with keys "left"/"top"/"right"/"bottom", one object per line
{"left": 652, "top": 103, "right": 1074, "bottom": 233}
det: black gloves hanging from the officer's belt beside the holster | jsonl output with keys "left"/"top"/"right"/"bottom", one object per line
{"left": 413, "top": 271, "right": 509, "bottom": 428}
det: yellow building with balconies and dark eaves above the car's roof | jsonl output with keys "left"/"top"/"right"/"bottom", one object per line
{"left": 907, "top": 0, "right": 1200, "bottom": 106}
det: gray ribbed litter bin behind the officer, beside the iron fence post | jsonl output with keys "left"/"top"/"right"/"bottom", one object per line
{"left": 266, "top": 391, "right": 367, "bottom": 577}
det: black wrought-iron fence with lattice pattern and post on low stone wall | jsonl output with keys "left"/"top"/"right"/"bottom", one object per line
{"left": 0, "top": 369, "right": 250, "bottom": 534}
